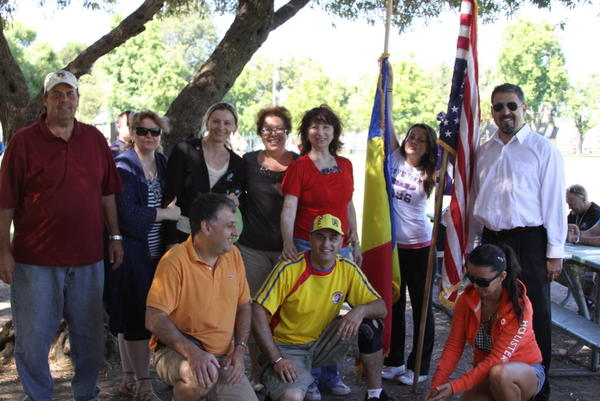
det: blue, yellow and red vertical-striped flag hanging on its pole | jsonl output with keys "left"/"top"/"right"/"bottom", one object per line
{"left": 361, "top": 54, "right": 400, "bottom": 352}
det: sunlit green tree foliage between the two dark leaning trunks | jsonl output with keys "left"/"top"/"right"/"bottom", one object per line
{"left": 89, "top": 15, "right": 217, "bottom": 115}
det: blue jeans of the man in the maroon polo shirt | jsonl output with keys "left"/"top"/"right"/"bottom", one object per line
{"left": 11, "top": 261, "right": 104, "bottom": 401}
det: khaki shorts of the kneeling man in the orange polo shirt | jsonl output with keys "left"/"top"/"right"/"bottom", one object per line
{"left": 153, "top": 346, "right": 258, "bottom": 401}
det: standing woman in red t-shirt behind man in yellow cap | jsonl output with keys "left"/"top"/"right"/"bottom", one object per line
{"left": 281, "top": 105, "right": 362, "bottom": 400}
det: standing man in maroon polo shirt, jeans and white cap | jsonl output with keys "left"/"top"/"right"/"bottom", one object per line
{"left": 0, "top": 71, "right": 123, "bottom": 401}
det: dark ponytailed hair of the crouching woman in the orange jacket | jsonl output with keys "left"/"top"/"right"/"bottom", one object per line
{"left": 469, "top": 244, "right": 525, "bottom": 321}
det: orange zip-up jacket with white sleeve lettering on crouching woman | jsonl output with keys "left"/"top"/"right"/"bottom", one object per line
{"left": 431, "top": 281, "right": 542, "bottom": 394}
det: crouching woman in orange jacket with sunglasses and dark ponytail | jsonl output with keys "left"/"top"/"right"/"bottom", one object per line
{"left": 425, "top": 244, "right": 545, "bottom": 401}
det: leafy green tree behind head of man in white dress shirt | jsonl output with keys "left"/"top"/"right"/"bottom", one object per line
{"left": 498, "top": 20, "right": 569, "bottom": 127}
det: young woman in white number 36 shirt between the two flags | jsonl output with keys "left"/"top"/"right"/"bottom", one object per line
{"left": 381, "top": 124, "right": 437, "bottom": 385}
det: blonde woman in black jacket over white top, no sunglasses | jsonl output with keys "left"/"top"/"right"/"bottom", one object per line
{"left": 165, "top": 102, "right": 243, "bottom": 246}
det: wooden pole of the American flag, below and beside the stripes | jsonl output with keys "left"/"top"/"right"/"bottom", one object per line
{"left": 412, "top": 147, "right": 448, "bottom": 393}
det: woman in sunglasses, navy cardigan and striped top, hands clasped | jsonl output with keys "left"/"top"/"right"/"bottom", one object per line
{"left": 108, "top": 110, "right": 180, "bottom": 401}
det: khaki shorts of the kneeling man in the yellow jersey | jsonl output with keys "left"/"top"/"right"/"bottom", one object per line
{"left": 259, "top": 317, "right": 356, "bottom": 400}
